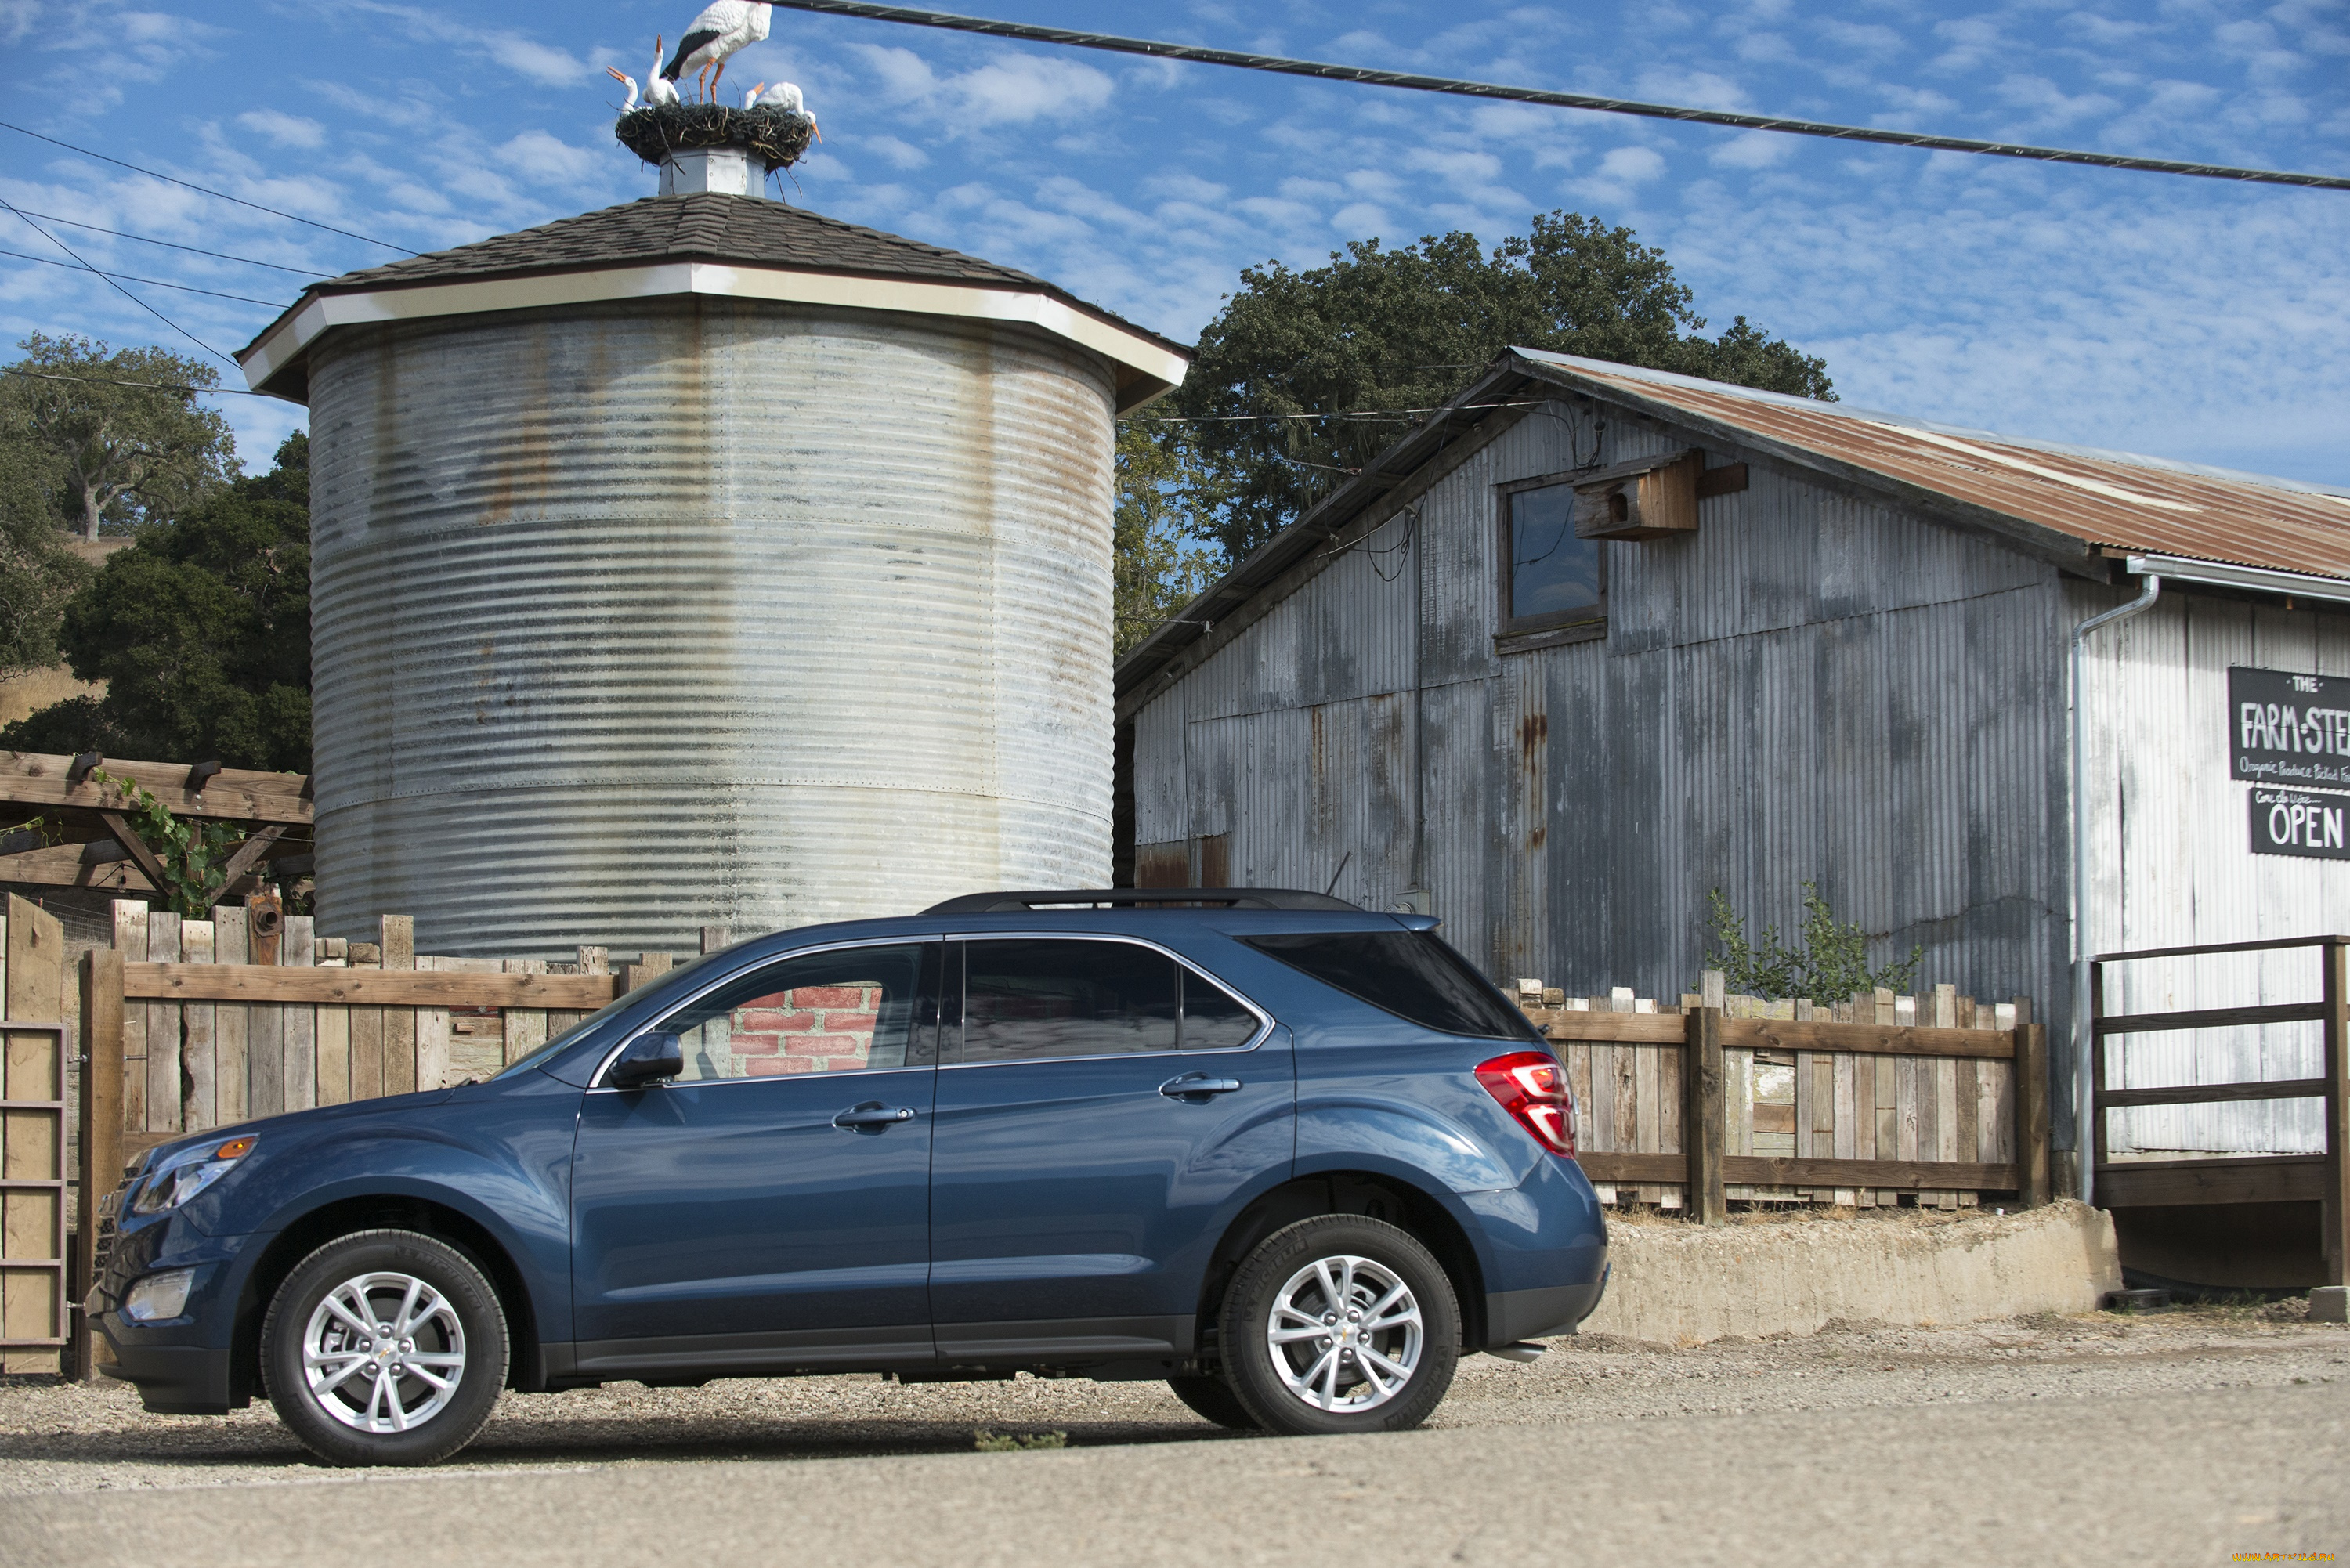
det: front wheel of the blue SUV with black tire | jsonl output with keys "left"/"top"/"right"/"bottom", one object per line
{"left": 261, "top": 1230, "right": 508, "bottom": 1465}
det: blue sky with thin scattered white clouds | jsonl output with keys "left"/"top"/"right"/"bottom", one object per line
{"left": 0, "top": 0, "right": 2350, "bottom": 484}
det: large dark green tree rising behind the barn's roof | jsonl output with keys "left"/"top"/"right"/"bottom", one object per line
{"left": 1166, "top": 211, "right": 1835, "bottom": 559}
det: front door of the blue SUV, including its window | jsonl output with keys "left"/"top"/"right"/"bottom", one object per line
{"left": 571, "top": 941, "right": 942, "bottom": 1375}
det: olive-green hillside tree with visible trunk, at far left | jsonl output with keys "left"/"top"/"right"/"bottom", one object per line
{"left": 0, "top": 331, "right": 237, "bottom": 538}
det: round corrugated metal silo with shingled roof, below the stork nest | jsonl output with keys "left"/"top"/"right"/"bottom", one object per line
{"left": 247, "top": 176, "right": 1182, "bottom": 955}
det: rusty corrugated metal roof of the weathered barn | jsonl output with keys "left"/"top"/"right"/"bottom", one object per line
{"left": 1516, "top": 348, "right": 2350, "bottom": 578}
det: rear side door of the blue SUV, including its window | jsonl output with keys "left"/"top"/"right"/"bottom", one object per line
{"left": 931, "top": 936, "right": 1295, "bottom": 1364}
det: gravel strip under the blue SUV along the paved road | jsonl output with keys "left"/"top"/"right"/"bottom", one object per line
{"left": 0, "top": 1302, "right": 2350, "bottom": 1494}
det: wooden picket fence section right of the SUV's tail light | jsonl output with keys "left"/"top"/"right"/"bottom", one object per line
{"left": 1518, "top": 974, "right": 2049, "bottom": 1218}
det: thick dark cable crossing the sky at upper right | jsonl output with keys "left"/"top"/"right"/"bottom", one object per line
{"left": 776, "top": 0, "right": 2350, "bottom": 190}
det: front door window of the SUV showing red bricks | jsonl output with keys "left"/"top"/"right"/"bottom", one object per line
{"left": 653, "top": 943, "right": 935, "bottom": 1082}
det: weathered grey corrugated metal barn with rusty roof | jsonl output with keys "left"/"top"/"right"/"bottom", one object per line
{"left": 1116, "top": 350, "right": 2350, "bottom": 1175}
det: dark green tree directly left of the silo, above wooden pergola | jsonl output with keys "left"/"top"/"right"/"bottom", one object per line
{"left": 0, "top": 432, "right": 310, "bottom": 773}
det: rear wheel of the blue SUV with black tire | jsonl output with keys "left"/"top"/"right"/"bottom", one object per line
{"left": 1217, "top": 1213, "right": 1462, "bottom": 1436}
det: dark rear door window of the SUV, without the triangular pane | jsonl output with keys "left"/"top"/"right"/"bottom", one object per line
{"left": 964, "top": 938, "right": 1180, "bottom": 1063}
